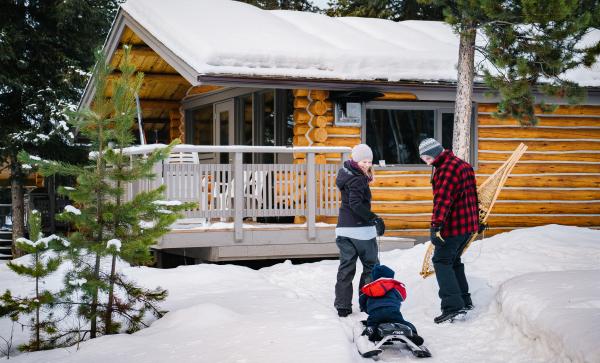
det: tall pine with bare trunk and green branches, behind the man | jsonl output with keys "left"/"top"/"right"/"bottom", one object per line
{"left": 420, "top": 0, "right": 600, "bottom": 159}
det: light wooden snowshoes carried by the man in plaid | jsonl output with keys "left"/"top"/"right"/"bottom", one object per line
{"left": 420, "top": 143, "right": 527, "bottom": 278}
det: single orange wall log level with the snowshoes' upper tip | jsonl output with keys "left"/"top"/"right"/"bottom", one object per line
{"left": 479, "top": 140, "right": 600, "bottom": 152}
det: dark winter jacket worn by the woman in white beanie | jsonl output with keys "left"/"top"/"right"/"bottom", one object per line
{"left": 335, "top": 161, "right": 377, "bottom": 227}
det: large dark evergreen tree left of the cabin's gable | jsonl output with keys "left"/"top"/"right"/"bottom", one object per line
{"left": 0, "top": 0, "right": 122, "bottom": 252}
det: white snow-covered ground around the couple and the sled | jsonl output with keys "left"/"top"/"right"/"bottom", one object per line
{"left": 0, "top": 225, "right": 600, "bottom": 363}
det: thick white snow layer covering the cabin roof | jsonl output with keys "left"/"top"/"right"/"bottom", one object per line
{"left": 122, "top": 0, "right": 600, "bottom": 86}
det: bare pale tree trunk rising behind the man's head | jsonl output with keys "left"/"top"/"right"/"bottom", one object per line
{"left": 452, "top": 25, "right": 477, "bottom": 161}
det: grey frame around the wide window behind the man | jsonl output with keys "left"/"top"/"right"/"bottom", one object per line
{"left": 361, "top": 101, "right": 478, "bottom": 170}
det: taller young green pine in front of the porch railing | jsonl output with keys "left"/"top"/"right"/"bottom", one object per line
{"left": 19, "top": 47, "right": 190, "bottom": 338}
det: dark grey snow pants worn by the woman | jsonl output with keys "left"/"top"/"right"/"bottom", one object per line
{"left": 334, "top": 236, "right": 379, "bottom": 309}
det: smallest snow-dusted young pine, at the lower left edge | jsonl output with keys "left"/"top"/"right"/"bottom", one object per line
{"left": 0, "top": 210, "right": 69, "bottom": 351}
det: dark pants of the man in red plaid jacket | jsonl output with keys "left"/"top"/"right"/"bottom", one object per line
{"left": 432, "top": 233, "right": 472, "bottom": 313}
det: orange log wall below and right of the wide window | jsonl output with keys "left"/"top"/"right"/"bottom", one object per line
{"left": 314, "top": 104, "right": 600, "bottom": 236}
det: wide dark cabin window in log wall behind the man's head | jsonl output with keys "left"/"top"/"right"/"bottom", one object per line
{"left": 363, "top": 102, "right": 475, "bottom": 168}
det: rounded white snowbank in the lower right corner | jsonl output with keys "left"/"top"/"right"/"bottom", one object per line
{"left": 496, "top": 270, "right": 600, "bottom": 362}
